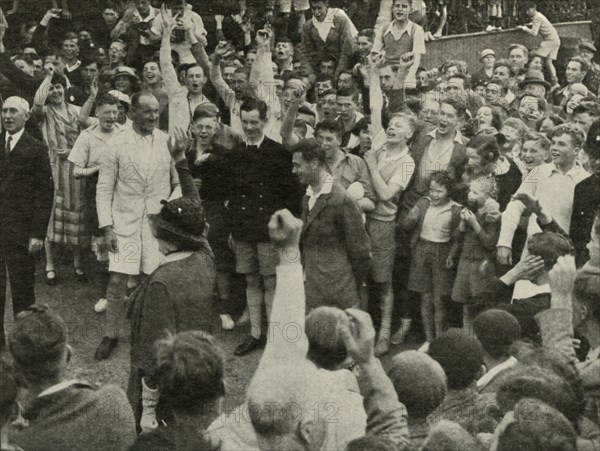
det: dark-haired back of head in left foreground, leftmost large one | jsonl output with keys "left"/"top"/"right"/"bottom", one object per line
{"left": 8, "top": 306, "right": 67, "bottom": 384}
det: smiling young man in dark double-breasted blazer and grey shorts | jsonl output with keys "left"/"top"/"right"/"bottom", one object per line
{"left": 220, "top": 99, "right": 301, "bottom": 356}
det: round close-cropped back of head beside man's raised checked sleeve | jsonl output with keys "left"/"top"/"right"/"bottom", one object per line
{"left": 388, "top": 351, "right": 447, "bottom": 419}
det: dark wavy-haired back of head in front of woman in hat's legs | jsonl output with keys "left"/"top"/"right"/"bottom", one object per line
{"left": 153, "top": 331, "right": 225, "bottom": 415}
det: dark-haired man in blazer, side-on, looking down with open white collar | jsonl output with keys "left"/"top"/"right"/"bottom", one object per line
{"left": 292, "top": 139, "right": 371, "bottom": 311}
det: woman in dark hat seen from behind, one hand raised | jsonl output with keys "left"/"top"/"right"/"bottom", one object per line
{"left": 127, "top": 129, "right": 216, "bottom": 429}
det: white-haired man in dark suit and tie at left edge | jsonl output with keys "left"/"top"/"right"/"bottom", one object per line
{"left": 0, "top": 97, "right": 54, "bottom": 346}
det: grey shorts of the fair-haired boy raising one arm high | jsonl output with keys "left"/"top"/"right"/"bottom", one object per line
{"left": 366, "top": 218, "right": 396, "bottom": 283}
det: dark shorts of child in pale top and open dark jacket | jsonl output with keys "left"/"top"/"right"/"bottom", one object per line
{"left": 408, "top": 240, "right": 454, "bottom": 296}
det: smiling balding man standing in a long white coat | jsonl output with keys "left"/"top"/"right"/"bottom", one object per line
{"left": 94, "top": 92, "right": 179, "bottom": 360}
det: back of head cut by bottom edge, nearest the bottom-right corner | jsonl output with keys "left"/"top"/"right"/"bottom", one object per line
{"left": 496, "top": 398, "right": 577, "bottom": 451}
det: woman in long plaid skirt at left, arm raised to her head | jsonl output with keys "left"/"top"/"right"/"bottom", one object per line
{"left": 32, "top": 63, "right": 88, "bottom": 285}
